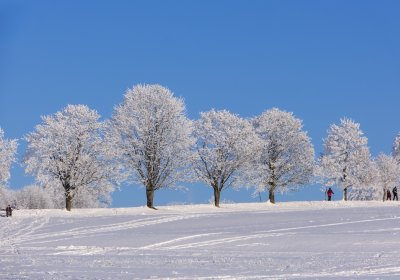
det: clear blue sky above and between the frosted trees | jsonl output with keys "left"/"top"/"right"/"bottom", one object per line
{"left": 0, "top": 0, "right": 400, "bottom": 207}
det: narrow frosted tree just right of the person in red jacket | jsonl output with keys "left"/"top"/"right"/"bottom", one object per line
{"left": 317, "top": 118, "right": 371, "bottom": 200}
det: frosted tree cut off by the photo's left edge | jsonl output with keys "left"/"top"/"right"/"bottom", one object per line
{"left": 0, "top": 128, "right": 18, "bottom": 185}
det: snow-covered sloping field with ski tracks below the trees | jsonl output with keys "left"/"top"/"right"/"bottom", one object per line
{"left": 0, "top": 202, "right": 400, "bottom": 279}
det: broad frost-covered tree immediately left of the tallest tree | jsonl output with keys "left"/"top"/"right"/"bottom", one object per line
{"left": 24, "top": 105, "right": 118, "bottom": 211}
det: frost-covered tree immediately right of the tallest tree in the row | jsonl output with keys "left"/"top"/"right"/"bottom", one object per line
{"left": 193, "top": 110, "right": 260, "bottom": 207}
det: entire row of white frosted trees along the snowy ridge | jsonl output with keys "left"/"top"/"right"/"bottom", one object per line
{"left": 0, "top": 85, "right": 400, "bottom": 210}
